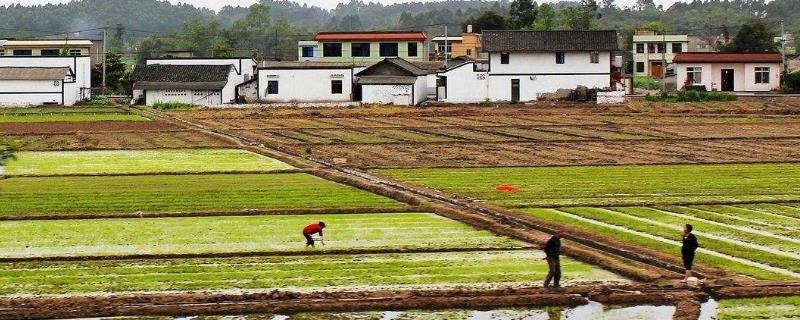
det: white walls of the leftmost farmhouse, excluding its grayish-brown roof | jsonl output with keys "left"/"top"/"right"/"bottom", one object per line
{"left": 0, "top": 56, "right": 92, "bottom": 106}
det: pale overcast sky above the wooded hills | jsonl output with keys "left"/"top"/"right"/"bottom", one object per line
{"left": 0, "top": 0, "right": 675, "bottom": 10}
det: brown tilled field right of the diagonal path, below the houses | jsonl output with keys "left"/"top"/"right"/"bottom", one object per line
{"left": 162, "top": 98, "right": 800, "bottom": 168}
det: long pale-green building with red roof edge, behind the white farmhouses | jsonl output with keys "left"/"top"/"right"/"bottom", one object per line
{"left": 297, "top": 31, "right": 427, "bottom": 63}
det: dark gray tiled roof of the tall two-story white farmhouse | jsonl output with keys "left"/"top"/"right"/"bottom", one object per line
{"left": 483, "top": 30, "right": 619, "bottom": 52}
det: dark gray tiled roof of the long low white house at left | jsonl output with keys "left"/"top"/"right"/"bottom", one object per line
{"left": 131, "top": 64, "right": 233, "bottom": 84}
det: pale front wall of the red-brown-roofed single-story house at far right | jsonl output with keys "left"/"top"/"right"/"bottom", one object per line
{"left": 675, "top": 63, "right": 781, "bottom": 91}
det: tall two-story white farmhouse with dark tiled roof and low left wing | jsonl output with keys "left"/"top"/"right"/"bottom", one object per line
{"left": 438, "top": 30, "right": 617, "bottom": 103}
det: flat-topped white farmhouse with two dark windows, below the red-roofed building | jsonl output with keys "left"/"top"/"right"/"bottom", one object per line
{"left": 257, "top": 61, "right": 366, "bottom": 103}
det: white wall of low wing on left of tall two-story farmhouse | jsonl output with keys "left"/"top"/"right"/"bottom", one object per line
{"left": 439, "top": 62, "right": 489, "bottom": 103}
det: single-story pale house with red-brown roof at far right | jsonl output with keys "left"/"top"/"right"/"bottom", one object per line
{"left": 675, "top": 52, "right": 783, "bottom": 92}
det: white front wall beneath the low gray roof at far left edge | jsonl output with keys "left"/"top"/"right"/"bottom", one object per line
{"left": 0, "top": 80, "right": 63, "bottom": 106}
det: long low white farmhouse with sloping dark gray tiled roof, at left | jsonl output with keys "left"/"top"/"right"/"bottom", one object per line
{"left": 131, "top": 64, "right": 239, "bottom": 106}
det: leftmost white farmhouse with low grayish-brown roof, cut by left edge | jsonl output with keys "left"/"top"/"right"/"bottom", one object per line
{"left": 0, "top": 56, "right": 92, "bottom": 106}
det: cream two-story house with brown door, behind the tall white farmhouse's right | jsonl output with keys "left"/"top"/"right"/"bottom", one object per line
{"left": 633, "top": 29, "right": 690, "bottom": 78}
